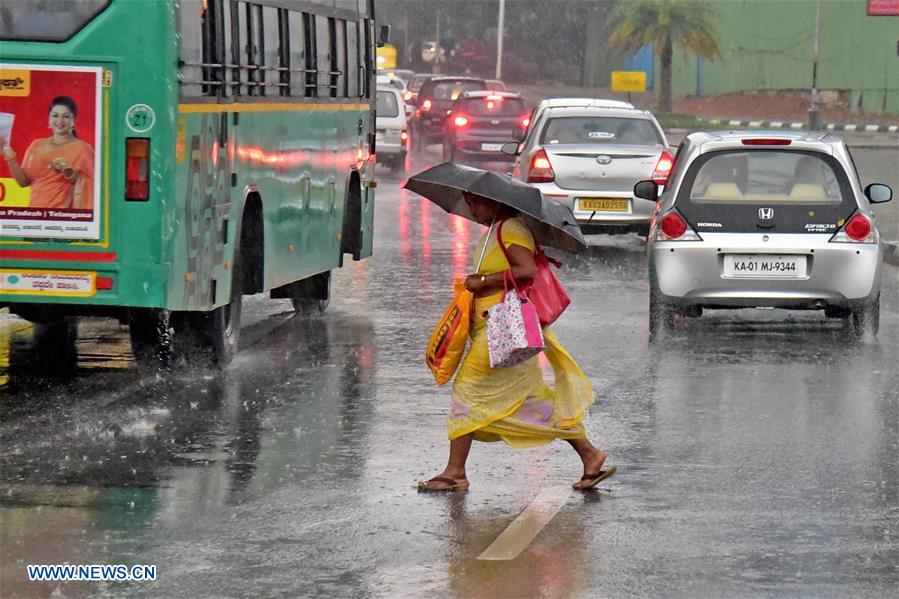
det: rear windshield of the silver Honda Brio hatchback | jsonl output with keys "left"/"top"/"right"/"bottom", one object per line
{"left": 690, "top": 150, "right": 843, "bottom": 204}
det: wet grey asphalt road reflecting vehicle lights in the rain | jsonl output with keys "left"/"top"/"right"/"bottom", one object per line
{"left": 0, "top": 146, "right": 899, "bottom": 597}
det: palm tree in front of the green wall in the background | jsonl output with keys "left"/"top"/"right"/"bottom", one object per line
{"left": 609, "top": 0, "right": 721, "bottom": 112}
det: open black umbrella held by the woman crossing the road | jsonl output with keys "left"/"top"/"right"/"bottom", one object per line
{"left": 403, "top": 162, "right": 587, "bottom": 253}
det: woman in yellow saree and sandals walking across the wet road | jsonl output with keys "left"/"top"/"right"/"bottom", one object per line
{"left": 410, "top": 180, "right": 616, "bottom": 491}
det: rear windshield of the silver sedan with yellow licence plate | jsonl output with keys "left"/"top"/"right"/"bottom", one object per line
{"left": 540, "top": 116, "right": 662, "bottom": 146}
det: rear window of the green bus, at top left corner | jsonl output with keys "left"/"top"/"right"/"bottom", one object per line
{"left": 0, "top": 0, "right": 111, "bottom": 42}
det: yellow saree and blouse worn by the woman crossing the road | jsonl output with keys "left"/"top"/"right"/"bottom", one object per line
{"left": 448, "top": 218, "right": 595, "bottom": 447}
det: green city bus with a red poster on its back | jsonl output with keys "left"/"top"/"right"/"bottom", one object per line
{"left": 0, "top": 0, "right": 386, "bottom": 366}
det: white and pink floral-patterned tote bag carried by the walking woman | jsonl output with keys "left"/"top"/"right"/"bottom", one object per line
{"left": 487, "top": 270, "right": 545, "bottom": 368}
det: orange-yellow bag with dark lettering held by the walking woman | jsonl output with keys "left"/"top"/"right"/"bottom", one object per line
{"left": 425, "top": 279, "right": 474, "bottom": 385}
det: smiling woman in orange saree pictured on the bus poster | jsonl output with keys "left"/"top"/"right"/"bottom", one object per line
{"left": 0, "top": 96, "right": 94, "bottom": 210}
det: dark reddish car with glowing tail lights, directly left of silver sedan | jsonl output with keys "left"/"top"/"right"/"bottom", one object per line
{"left": 443, "top": 91, "right": 531, "bottom": 162}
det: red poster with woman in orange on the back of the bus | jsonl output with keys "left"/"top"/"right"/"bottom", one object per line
{"left": 0, "top": 63, "right": 103, "bottom": 239}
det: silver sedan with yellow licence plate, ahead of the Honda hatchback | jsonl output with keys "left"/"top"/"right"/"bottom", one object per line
{"left": 503, "top": 104, "right": 672, "bottom": 234}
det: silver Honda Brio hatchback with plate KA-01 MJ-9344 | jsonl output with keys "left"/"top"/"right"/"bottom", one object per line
{"left": 634, "top": 131, "right": 892, "bottom": 336}
